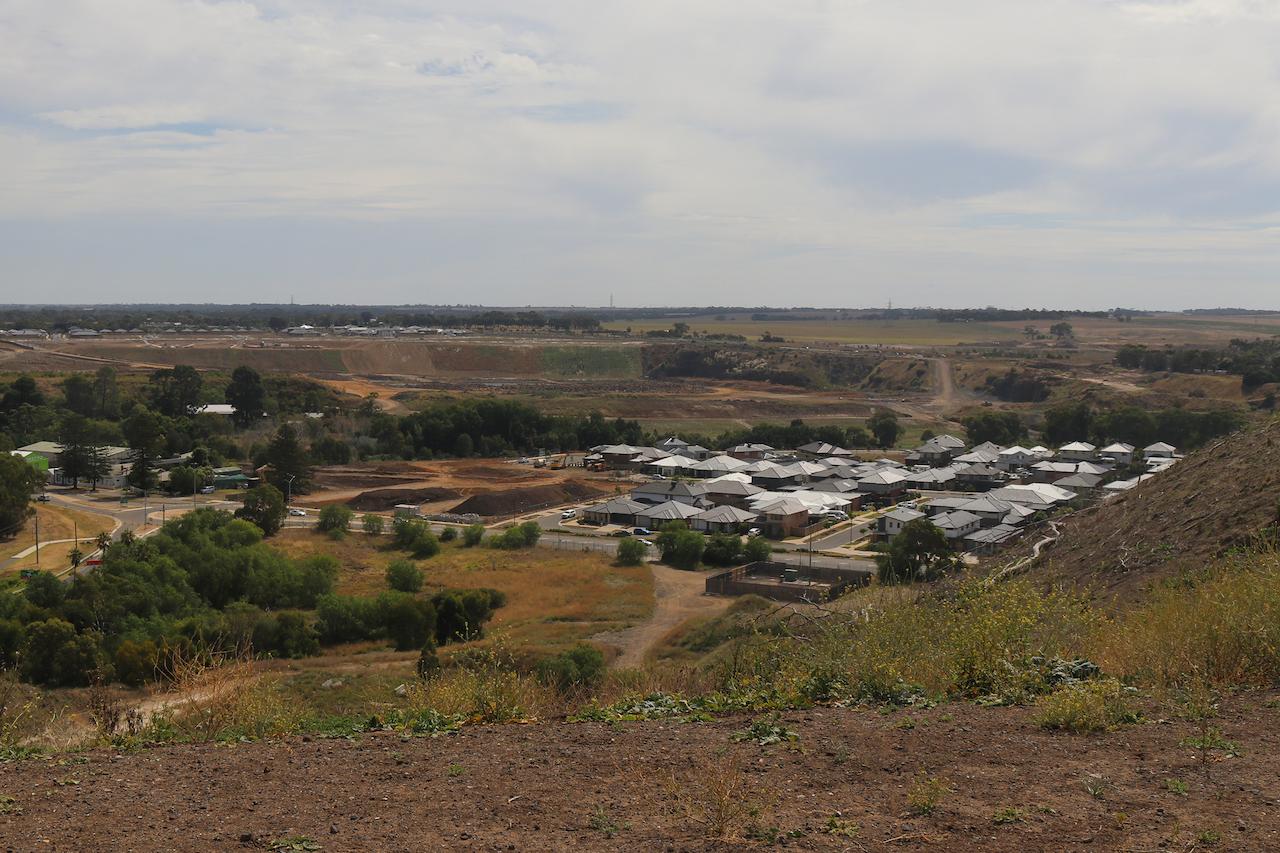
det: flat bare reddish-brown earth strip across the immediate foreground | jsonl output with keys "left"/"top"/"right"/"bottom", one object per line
{"left": 0, "top": 693, "right": 1280, "bottom": 850}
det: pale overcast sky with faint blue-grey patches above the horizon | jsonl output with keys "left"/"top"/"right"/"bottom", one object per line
{"left": 0, "top": 0, "right": 1280, "bottom": 307}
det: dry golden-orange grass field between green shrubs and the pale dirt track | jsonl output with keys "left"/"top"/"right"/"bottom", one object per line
{"left": 274, "top": 530, "right": 654, "bottom": 649}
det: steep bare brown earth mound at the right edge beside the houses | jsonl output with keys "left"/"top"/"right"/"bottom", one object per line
{"left": 1030, "top": 418, "right": 1280, "bottom": 597}
